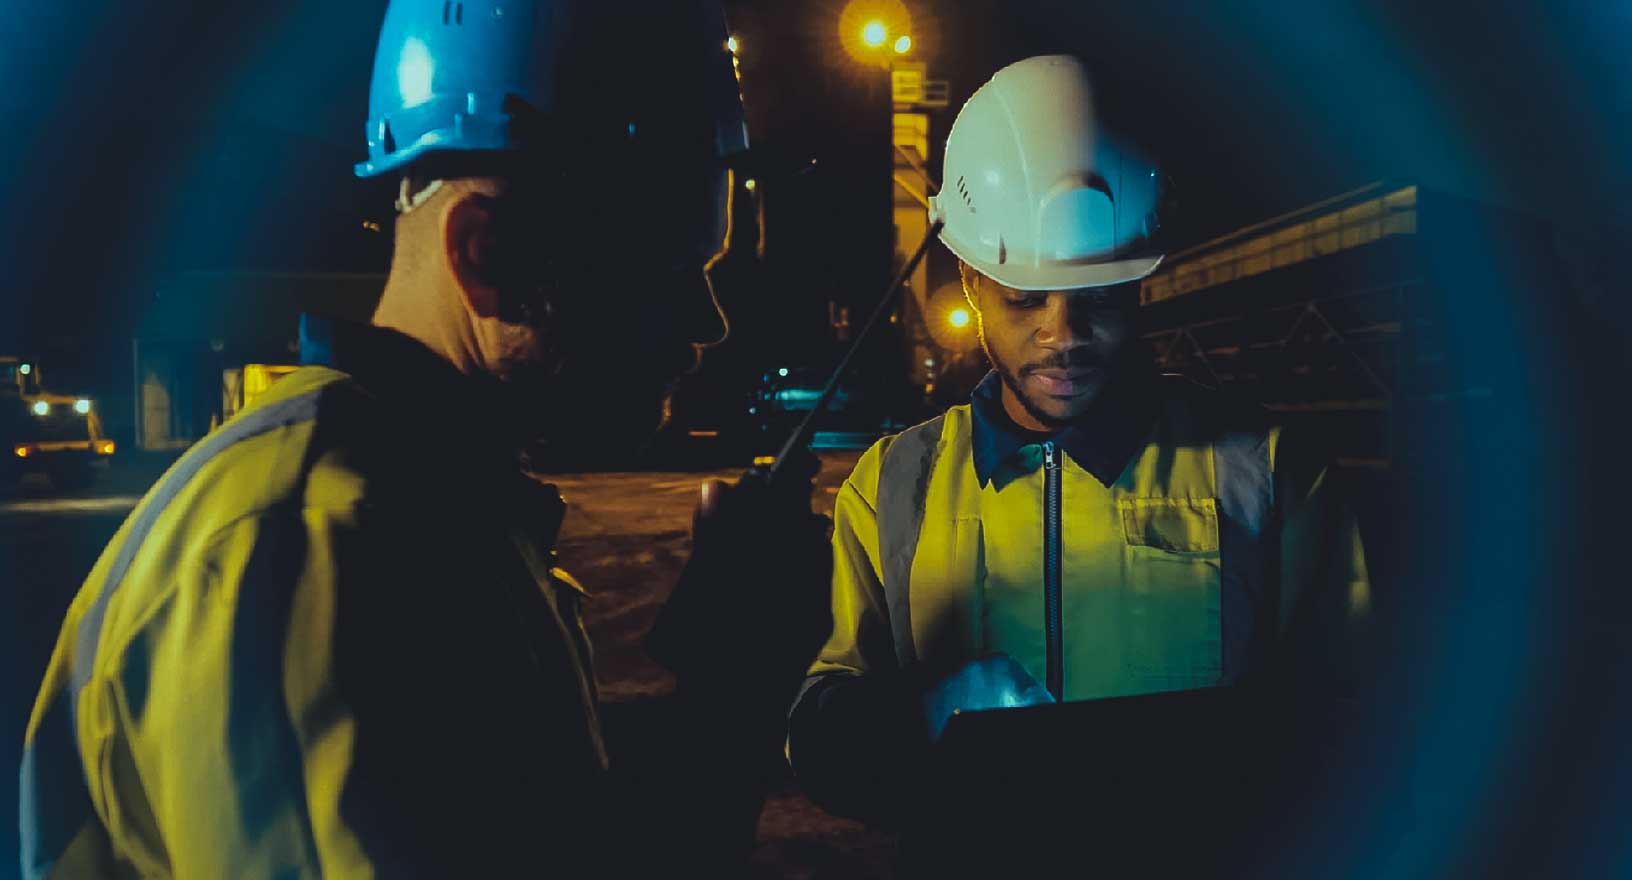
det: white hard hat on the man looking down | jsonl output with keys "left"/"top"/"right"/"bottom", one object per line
{"left": 930, "top": 56, "right": 1162, "bottom": 291}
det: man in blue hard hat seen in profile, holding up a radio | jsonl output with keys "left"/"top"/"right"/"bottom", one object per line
{"left": 21, "top": 0, "right": 831, "bottom": 877}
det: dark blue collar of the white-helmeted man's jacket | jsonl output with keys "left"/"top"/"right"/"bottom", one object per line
{"left": 969, "top": 362, "right": 1160, "bottom": 487}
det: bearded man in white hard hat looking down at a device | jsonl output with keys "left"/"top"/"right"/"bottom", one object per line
{"left": 788, "top": 56, "right": 1369, "bottom": 842}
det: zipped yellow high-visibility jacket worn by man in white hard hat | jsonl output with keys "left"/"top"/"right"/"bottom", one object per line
{"left": 790, "top": 374, "right": 1371, "bottom": 789}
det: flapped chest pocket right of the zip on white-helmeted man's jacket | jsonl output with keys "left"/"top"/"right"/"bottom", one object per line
{"left": 1116, "top": 498, "right": 1222, "bottom": 691}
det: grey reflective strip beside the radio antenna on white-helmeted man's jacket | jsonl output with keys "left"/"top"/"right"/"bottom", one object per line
{"left": 878, "top": 415, "right": 947, "bottom": 666}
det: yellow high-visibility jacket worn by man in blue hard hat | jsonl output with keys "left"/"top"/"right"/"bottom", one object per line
{"left": 21, "top": 333, "right": 605, "bottom": 878}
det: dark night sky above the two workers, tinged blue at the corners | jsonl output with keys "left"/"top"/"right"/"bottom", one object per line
{"left": 0, "top": 0, "right": 1632, "bottom": 372}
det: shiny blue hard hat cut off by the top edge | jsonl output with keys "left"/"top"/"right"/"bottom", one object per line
{"left": 356, "top": 0, "right": 747, "bottom": 178}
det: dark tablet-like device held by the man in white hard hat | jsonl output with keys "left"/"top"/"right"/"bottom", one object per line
{"left": 904, "top": 687, "right": 1281, "bottom": 869}
